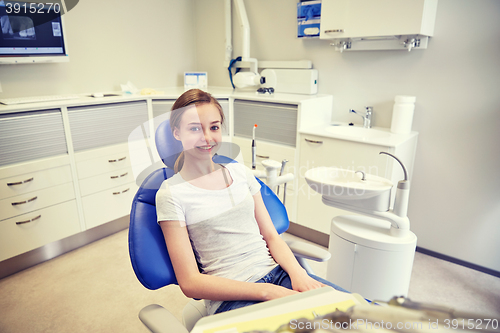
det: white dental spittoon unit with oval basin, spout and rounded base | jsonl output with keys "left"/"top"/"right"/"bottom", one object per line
{"left": 305, "top": 152, "right": 417, "bottom": 300}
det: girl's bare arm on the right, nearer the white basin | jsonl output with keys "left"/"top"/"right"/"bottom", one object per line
{"left": 253, "top": 191, "right": 324, "bottom": 292}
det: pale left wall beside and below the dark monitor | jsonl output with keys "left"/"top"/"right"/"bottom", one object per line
{"left": 0, "top": 0, "right": 196, "bottom": 98}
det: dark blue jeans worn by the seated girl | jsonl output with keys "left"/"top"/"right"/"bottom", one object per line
{"left": 215, "top": 265, "right": 348, "bottom": 313}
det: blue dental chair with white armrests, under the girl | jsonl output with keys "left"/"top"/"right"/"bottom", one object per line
{"left": 129, "top": 120, "right": 330, "bottom": 333}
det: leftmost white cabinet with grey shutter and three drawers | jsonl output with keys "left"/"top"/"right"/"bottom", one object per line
{"left": 0, "top": 109, "right": 80, "bottom": 261}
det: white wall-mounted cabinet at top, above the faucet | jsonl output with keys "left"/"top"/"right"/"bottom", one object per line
{"left": 320, "top": 0, "right": 437, "bottom": 50}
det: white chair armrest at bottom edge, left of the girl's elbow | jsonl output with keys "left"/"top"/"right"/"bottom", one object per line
{"left": 139, "top": 304, "right": 189, "bottom": 333}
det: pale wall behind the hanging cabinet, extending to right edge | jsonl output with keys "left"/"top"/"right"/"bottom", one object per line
{"left": 195, "top": 0, "right": 500, "bottom": 271}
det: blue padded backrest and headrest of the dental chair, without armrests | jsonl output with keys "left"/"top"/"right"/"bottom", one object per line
{"left": 128, "top": 120, "right": 289, "bottom": 290}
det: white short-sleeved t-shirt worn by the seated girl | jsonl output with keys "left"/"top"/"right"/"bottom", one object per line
{"left": 156, "top": 163, "right": 277, "bottom": 314}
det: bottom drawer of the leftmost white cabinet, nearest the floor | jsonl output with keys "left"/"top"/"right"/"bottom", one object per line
{"left": 0, "top": 200, "right": 80, "bottom": 261}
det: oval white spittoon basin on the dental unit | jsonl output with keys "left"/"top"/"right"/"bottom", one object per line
{"left": 305, "top": 167, "right": 393, "bottom": 211}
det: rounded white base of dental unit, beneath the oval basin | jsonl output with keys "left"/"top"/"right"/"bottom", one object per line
{"left": 326, "top": 215, "right": 417, "bottom": 301}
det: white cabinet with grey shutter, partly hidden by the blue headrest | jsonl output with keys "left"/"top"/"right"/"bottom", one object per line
{"left": 68, "top": 101, "right": 150, "bottom": 229}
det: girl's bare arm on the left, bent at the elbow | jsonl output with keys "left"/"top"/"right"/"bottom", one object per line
{"left": 160, "top": 221, "right": 295, "bottom": 301}
